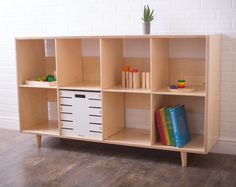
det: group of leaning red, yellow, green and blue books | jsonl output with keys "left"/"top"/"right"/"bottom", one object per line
{"left": 155, "top": 105, "right": 190, "bottom": 147}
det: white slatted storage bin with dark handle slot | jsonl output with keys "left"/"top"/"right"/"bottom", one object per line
{"left": 59, "top": 90, "right": 102, "bottom": 140}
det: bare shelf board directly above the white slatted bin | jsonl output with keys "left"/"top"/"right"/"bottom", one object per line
{"left": 59, "top": 81, "right": 101, "bottom": 90}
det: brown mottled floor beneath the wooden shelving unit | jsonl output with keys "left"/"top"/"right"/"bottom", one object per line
{"left": 0, "top": 129, "right": 236, "bottom": 187}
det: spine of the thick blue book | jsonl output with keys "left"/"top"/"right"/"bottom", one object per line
{"left": 170, "top": 109, "right": 181, "bottom": 147}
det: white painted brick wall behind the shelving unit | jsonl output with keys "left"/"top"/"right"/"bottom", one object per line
{"left": 0, "top": 0, "right": 236, "bottom": 154}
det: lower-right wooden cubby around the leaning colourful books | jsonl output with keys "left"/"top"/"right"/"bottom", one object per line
{"left": 151, "top": 94, "right": 205, "bottom": 153}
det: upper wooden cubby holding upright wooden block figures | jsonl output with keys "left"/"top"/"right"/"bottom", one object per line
{"left": 101, "top": 38, "right": 150, "bottom": 93}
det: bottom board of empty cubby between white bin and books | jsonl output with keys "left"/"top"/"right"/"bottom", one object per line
{"left": 104, "top": 128, "right": 150, "bottom": 147}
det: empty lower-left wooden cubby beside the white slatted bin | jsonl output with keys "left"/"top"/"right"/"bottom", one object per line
{"left": 19, "top": 88, "right": 59, "bottom": 136}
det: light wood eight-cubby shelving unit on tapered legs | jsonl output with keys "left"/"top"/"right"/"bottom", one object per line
{"left": 16, "top": 35, "right": 221, "bottom": 166}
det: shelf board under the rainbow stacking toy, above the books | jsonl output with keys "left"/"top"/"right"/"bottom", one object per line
{"left": 152, "top": 86, "right": 206, "bottom": 97}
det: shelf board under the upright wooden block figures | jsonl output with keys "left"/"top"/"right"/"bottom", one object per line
{"left": 103, "top": 85, "right": 151, "bottom": 93}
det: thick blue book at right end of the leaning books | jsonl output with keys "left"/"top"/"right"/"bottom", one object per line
{"left": 169, "top": 105, "right": 190, "bottom": 147}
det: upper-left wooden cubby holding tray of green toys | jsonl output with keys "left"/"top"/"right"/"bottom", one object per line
{"left": 16, "top": 39, "right": 57, "bottom": 89}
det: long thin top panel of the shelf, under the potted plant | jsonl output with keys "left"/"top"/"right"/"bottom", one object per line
{"left": 15, "top": 33, "right": 219, "bottom": 40}
